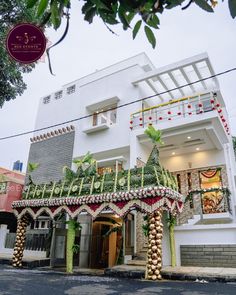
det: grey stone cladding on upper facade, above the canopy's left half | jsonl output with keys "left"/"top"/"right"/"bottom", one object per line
{"left": 27, "top": 131, "right": 75, "bottom": 184}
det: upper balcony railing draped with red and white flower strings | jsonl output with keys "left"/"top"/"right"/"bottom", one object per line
{"left": 130, "top": 93, "right": 229, "bottom": 134}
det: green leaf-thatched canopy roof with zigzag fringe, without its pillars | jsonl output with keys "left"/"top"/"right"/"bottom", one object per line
{"left": 12, "top": 146, "right": 185, "bottom": 219}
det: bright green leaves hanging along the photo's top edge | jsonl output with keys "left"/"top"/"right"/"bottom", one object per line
{"left": 21, "top": 0, "right": 236, "bottom": 48}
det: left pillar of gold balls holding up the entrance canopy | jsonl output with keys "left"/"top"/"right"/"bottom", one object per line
{"left": 12, "top": 215, "right": 29, "bottom": 267}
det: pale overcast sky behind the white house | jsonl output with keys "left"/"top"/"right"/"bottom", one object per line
{"left": 0, "top": 0, "right": 236, "bottom": 170}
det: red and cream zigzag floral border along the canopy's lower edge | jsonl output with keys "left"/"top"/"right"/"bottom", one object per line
{"left": 12, "top": 186, "right": 185, "bottom": 218}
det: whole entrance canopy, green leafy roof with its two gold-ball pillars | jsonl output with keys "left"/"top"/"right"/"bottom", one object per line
{"left": 12, "top": 146, "right": 185, "bottom": 280}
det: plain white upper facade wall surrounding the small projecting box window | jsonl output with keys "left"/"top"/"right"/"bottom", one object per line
{"left": 32, "top": 54, "right": 154, "bottom": 164}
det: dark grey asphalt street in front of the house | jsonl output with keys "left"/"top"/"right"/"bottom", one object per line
{"left": 0, "top": 265, "right": 236, "bottom": 295}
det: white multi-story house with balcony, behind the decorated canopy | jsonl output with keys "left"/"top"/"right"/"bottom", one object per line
{"left": 22, "top": 53, "right": 236, "bottom": 267}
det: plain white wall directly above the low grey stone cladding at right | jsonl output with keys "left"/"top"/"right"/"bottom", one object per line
{"left": 175, "top": 223, "right": 236, "bottom": 266}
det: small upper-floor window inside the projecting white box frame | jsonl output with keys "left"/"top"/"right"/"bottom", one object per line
{"left": 93, "top": 106, "right": 117, "bottom": 126}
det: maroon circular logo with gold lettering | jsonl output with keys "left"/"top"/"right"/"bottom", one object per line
{"left": 6, "top": 23, "right": 47, "bottom": 64}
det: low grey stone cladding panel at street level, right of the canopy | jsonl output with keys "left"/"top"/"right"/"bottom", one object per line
{"left": 180, "top": 245, "right": 236, "bottom": 267}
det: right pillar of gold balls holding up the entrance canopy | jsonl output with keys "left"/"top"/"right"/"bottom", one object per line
{"left": 145, "top": 209, "right": 163, "bottom": 281}
